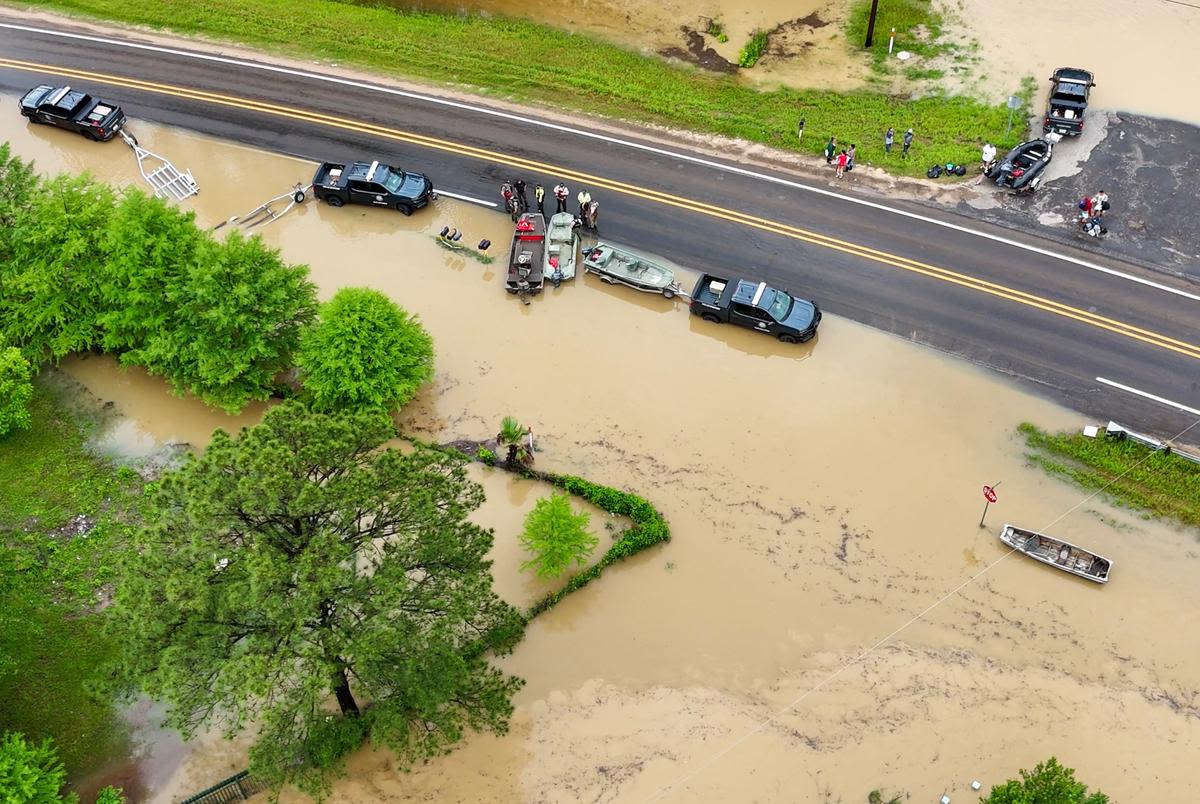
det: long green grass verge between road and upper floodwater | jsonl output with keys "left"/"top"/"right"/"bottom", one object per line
{"left": 23, "top": 0, "right": 1021, "bottom": 175}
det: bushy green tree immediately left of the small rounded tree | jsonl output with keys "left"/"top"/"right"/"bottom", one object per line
{"left": 130, "top": 232, "right": 317, "bottom": 412}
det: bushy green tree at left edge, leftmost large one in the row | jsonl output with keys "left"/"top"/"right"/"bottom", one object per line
{"left": 0, "top": 176, "right": 114, "bottom": 362}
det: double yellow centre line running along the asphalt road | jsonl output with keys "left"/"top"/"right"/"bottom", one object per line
{"left": 9, "top": 58, "right": 1200, "bottom": 360}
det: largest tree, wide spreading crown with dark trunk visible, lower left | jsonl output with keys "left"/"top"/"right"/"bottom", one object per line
{"left": 110, "top": 402, "right": 523, "bottom": 794}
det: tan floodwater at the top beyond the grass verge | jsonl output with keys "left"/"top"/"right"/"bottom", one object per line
{"left": 386, "top": 0, "right": 1200, "bottom": 124}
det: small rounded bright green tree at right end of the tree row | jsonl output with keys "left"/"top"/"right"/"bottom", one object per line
{"left": 296, "top": 288, "right": 433, "bottom": 410}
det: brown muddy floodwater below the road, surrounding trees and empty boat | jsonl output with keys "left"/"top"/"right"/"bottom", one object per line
{"left": 0, "top": 110, "right": 1200, "bottom": 804}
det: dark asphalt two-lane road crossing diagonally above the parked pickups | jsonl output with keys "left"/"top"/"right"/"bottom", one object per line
{"left": 0, "top": 14, "right": 1200, "bottom": 442}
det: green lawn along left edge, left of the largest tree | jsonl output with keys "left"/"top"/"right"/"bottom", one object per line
{"left": 0, "top": 386, "right": 140, "bottom": 782}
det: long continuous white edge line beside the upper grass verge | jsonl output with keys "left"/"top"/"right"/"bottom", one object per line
{"left": 7, "top": 23, "right": 1200, "bottom": 301}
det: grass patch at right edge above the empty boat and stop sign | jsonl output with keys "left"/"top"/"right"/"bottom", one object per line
{"left": 1018, "top": 422, "right": 1200, "bottom": 527}
